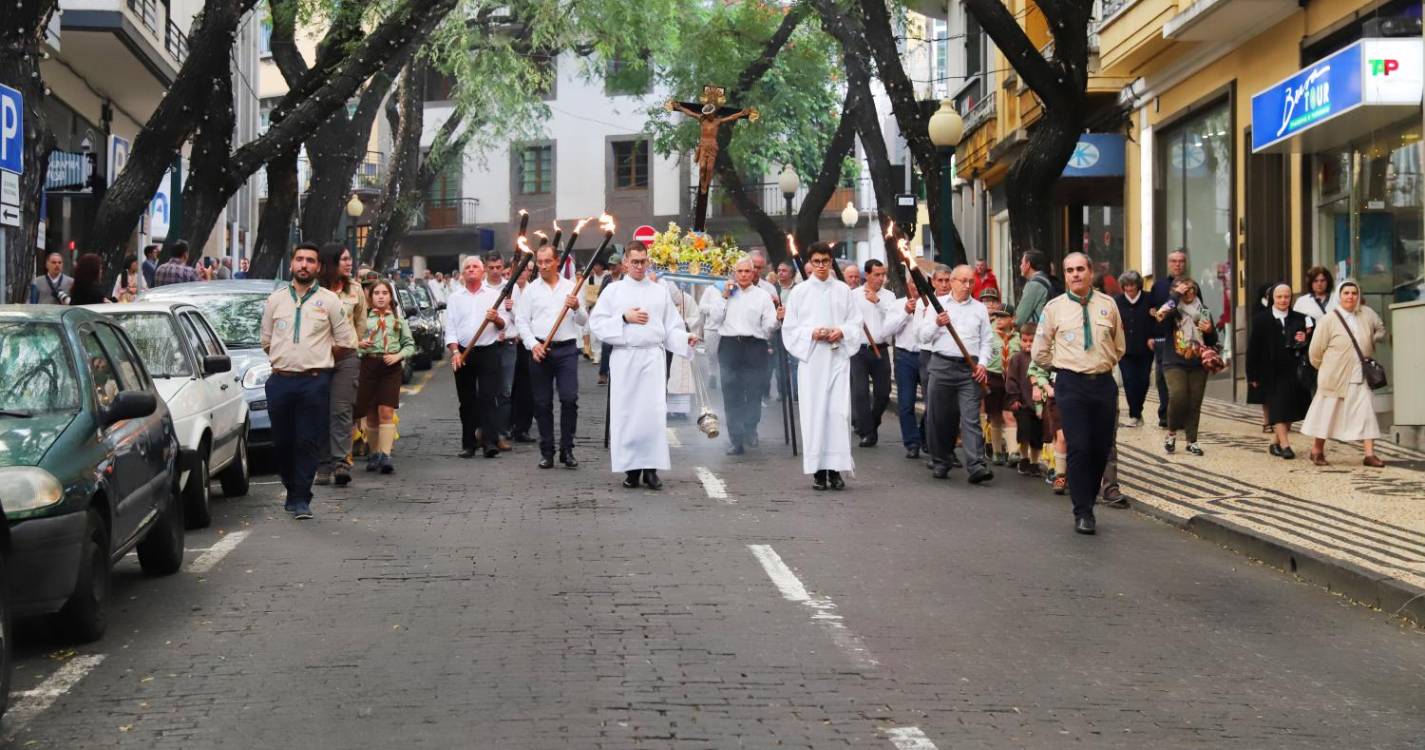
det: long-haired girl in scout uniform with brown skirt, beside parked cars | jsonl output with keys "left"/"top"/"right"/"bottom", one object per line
{"left": 356, "top": 279, "right": 416, "bottom": 473}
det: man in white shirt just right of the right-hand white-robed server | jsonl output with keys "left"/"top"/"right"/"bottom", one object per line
{"left": 851, "top": 258, "right": 911, "bottom": 448}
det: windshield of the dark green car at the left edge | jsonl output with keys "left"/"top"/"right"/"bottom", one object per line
{"left": 0, "top": 322, "right": 80, "bottom": 419}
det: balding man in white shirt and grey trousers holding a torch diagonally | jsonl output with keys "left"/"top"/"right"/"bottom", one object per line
{"left": 918, "top": 265, "right": 995, "bottom": 485}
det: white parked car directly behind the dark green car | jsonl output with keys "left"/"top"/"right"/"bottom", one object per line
{"left": 90, "top": 301, "right": 248, "bottom": 529}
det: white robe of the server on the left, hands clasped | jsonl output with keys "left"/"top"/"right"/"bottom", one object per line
{"left": 589, "top": 278, "right": 693, "bottom": 472}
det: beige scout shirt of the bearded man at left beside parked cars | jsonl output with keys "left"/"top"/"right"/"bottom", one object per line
{"left": 262, "top": 282, "right": 356, "bottom": 372}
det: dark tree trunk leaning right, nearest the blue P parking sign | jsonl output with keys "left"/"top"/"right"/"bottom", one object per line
{"left": 90, "top": 0, "right": 257, "bottom": 265}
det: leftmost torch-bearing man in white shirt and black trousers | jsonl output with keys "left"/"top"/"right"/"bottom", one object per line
{"left": 446, "top": 255, "right": 513, "bottom": 458}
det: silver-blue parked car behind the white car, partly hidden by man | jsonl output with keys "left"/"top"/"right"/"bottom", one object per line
{"left": 138, "top": 278, "right": 285, "bottom": 449}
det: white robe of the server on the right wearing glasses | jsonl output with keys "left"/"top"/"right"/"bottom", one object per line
{"left": 782, "top": 277, "right": 865, "bottom": 473}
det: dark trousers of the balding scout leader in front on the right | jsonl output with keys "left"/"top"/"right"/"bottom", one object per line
{"left": 1055, "top": 369, "right": 1119, "bottom": 518}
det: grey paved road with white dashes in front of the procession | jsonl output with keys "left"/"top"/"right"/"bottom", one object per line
{"left": 3, "top": 365, "right": 1425, "bottom": 750}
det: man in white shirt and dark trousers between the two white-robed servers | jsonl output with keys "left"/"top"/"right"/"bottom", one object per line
{"left": 704, "top": 258, "right": 777, "bottom": 456}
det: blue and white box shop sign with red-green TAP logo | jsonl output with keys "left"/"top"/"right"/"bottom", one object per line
{"left": 1251, "top": 38, "right": 1425, "bottom": 153}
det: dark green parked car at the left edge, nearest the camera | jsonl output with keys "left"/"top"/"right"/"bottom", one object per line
{"left": 0, "top": 305, "right": 184, "bottom": 642}
